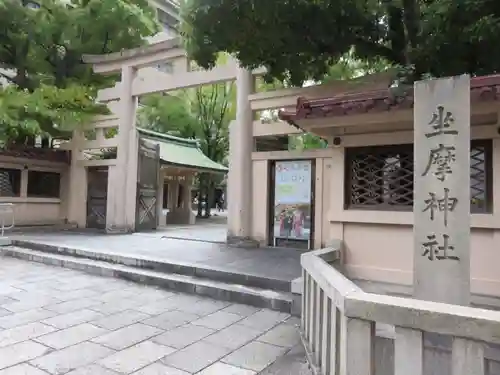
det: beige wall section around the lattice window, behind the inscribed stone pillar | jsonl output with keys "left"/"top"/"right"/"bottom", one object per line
{"left": 336, "top": 129, "right": 500, "bottom": 296}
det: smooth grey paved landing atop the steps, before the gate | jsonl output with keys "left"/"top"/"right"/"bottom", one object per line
{"left": 10, "top": 234, "right": 302, "bottom": 281}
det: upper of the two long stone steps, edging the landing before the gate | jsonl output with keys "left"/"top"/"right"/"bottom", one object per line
{"left": 12, "top": 239, "right": 291, "bottom": 293}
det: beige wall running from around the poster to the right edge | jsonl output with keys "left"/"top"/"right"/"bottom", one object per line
{"left": 253, "top": 124, "right": 500, "bottom": 296}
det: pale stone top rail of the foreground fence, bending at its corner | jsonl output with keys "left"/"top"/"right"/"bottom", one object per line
{"left": 301, "top": 249, "right": 500, "bottom": 343}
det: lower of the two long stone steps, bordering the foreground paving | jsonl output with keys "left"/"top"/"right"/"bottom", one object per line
{"left": 0, "top": 246, "right": 292, "bottom": 313}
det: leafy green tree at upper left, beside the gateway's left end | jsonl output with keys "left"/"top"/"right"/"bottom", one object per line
{"left": 0, "top": 0, "right": 158, "bottom": 142}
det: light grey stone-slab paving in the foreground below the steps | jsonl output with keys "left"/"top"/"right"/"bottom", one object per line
{"left": 0, "top": 257, "right": 309, "bottom": 375}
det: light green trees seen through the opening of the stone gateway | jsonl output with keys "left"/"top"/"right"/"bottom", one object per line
{"left": 138, "top": 83, "right": 235, "bottom": 217}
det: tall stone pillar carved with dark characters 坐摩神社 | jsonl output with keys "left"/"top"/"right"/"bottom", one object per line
{"left": 413, "top": 75, "right": 470, "bottom": 305}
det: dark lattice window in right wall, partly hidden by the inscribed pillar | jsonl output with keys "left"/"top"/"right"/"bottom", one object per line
{"left": 345, "top": 141, "right": 492, "bottom": 213}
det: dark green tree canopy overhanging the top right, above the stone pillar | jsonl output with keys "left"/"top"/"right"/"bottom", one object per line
{"left": 182, "top": 0, "right": 500, "bottom": 85}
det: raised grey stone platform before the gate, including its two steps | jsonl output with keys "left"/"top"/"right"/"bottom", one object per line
{"left": 1, "top": 233, "right": 300, "bottom": 312}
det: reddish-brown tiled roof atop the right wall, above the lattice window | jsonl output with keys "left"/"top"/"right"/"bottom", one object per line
{"left": 279, "top": 75, "right": 500, "bottom": 123}
